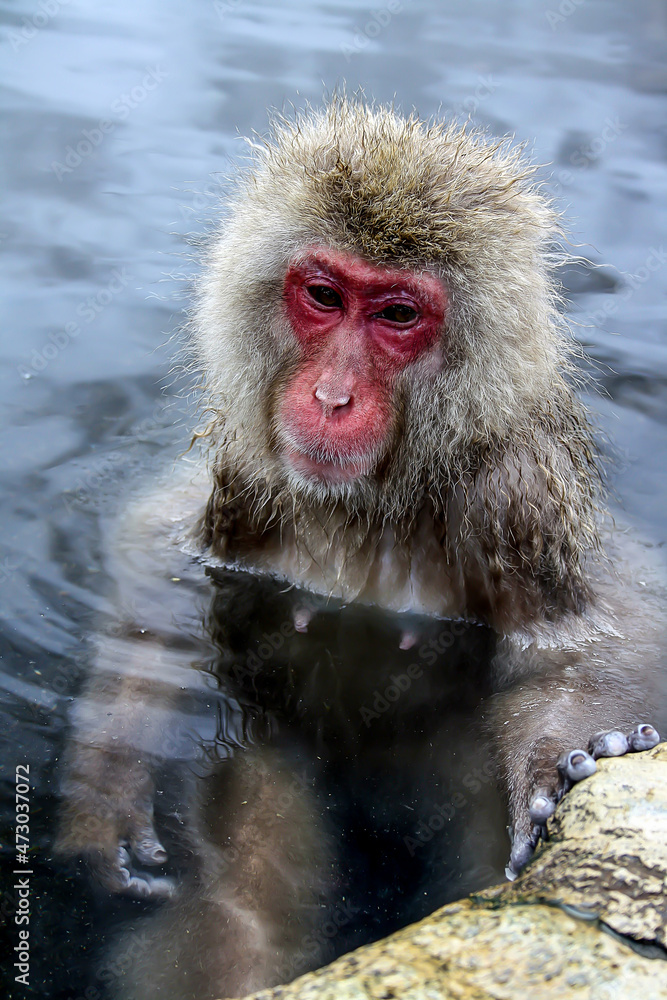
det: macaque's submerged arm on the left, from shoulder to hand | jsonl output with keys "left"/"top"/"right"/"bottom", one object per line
{"left": 57, "top": 464, "right": 215, "bottom": 895}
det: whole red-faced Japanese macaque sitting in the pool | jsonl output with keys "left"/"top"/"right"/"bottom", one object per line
{"left": 59, "top": 98, "right": 664, "bottom": 1000}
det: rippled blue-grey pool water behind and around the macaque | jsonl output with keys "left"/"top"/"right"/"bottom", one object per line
{"left": 0, "top": 0, "right": 667, "bottom": 996}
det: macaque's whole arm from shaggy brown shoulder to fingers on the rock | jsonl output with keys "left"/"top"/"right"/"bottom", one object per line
{"left": 451, "top": 442, "right": 666, "bottom": 871}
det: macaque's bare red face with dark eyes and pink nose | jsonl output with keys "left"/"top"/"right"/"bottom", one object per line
{"left": 278, "top": 249, "right": 446, "bottom": 484}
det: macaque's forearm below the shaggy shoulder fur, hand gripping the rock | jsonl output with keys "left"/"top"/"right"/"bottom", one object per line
{"left": 490, "top": 535, "right": 666, "bottom": 876}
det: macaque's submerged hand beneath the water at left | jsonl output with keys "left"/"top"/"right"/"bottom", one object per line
{"left": 56, "top": 744, "right": 174, "bottom": 899}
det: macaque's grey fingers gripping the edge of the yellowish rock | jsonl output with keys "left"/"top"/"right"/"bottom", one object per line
{"left": 505, "top": 723, "right": 660, "bottom": 881}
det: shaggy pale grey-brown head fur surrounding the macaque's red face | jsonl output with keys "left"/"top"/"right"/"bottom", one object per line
{"left": 194, "top": 98, "right": 598, "bottom": 616}
